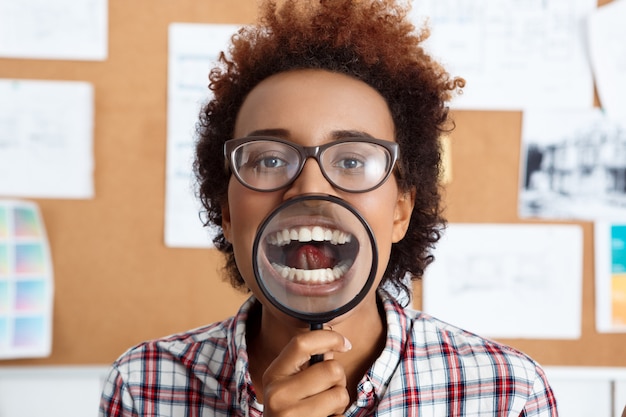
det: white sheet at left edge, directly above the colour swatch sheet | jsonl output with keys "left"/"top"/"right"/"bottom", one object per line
{"left": 0, "top": 79, "right": 94, "bottom": 198}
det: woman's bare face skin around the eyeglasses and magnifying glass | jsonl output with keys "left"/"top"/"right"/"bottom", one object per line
{"left": 222, "top": 70, "right": 413, "bottom": 322}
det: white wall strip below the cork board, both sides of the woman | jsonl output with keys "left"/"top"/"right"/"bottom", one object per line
{"left": 0, "top": 366, "right": 626, "bottom": 417}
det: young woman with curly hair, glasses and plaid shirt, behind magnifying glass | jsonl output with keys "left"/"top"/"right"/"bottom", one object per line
{"left": 100, "top": 0, "right": 557, "bottom": 416}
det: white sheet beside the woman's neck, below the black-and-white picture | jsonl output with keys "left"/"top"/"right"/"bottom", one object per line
{"left": 423, "top": 223, "right": 583, "bottom": 339}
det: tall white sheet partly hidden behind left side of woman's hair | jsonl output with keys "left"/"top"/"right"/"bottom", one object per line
{"left": 165, "top": 23, "right": 239, "bottom": 247}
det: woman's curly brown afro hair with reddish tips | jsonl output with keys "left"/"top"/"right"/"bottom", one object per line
{"left": 194, "top": 0, "right": 465, "bottom": 306}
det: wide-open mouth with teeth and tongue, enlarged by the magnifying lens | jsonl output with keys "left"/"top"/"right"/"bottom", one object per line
{"left": 266, "top": 226, "right": 359, "bottom": 285}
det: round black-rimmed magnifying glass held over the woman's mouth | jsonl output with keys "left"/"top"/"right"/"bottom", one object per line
{"left": 252, "top": 194, "right": 378, "bottom": 363}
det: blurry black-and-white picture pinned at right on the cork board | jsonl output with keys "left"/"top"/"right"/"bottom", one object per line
{"left": 519, "top": 109, "right": 626, "bottom": 220}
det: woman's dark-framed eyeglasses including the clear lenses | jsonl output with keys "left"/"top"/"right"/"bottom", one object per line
{"left": 224, "top": 136, "right": 398, "bottom": 193}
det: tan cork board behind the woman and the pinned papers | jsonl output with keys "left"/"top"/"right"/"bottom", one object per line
{"left": 0, "top": 0, "right": 626, "bottom": 366}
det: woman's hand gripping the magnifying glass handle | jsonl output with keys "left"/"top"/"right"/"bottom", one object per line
{"left": 263, "top": 330, "right": 352, "bottom": 417}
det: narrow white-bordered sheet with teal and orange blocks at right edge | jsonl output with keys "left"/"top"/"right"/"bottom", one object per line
{"left": 594, "top": 221, "right": 626, "bottom": 333}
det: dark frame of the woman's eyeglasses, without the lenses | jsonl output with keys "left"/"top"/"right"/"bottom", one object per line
{"left": 224, "top": 136, "right": 400, "bottom": 193}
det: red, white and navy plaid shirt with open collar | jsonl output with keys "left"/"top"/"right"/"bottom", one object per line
{"left": 100, "top": 291, "right": 557, "bottom": 417}
